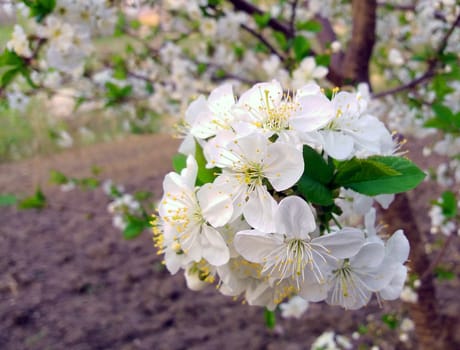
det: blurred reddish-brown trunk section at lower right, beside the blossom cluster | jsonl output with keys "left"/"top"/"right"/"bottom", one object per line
{"left": 382, "top": 193, "right": 450, "bottom": 350}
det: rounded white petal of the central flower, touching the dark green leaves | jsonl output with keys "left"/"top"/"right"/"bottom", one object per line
{"left": 264, "top": 142, "right": 304, "bottom": 191}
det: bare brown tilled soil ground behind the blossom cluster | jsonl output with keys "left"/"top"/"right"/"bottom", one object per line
{"left": 0, "top": 136, "right": 460, "bottom": 350}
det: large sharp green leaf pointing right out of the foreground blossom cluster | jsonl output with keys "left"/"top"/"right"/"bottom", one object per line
{"left": 334, "top": 156, "right": 425, "bottom": 196}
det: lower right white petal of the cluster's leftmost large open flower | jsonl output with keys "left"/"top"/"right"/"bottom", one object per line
{"left": 201, "top": 225, "right": 230, "bottom": 266}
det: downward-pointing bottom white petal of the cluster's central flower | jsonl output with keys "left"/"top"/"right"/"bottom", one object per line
{"left": 243, "top": 186, "right": 278, "bottom": 233}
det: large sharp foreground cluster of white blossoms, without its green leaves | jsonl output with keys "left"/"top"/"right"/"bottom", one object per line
{"left": 154, "top": 81, "right": 409, "bottom": 309}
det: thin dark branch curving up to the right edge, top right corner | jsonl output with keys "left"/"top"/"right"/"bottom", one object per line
{"left": 373, "top": 14, "right": 460, "bottom": 98}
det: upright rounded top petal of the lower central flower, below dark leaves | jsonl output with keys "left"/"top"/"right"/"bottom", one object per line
{"left": 275, "top": 196, "right": 316, "bottom": 239}
